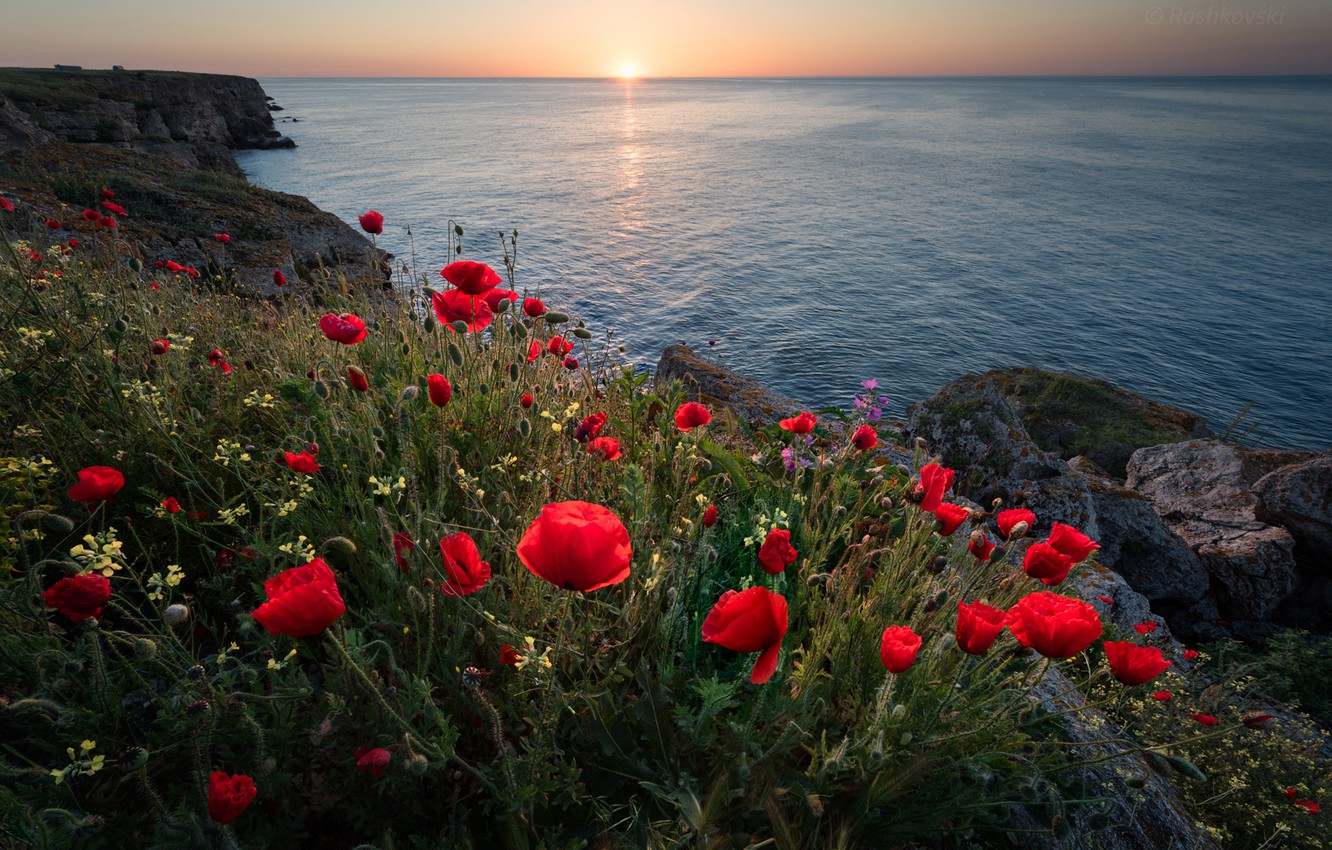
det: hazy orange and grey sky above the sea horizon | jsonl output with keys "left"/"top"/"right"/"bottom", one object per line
{"left": 0, "top": 0, "right": 1332, "bottom": 77}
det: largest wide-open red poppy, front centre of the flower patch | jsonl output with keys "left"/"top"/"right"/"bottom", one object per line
{"left": 518, "top": 501, "right": 633, "bottom": 593}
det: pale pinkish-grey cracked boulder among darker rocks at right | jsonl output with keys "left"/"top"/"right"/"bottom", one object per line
{"left": 1127, "top": 440, "right": 1296, "bottom": 620}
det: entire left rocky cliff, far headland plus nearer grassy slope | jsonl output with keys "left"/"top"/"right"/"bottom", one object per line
{"left": 0, "top": 68, "right": 389, "bottom": 294}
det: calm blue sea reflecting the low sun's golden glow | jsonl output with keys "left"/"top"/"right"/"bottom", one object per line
{"left": 237, "top": 77, "right": 1332, "bottom": 450}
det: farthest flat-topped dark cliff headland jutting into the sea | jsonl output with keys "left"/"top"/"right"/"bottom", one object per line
{"left": 0, "top": 68, "right": 296, "bottom": 177}
